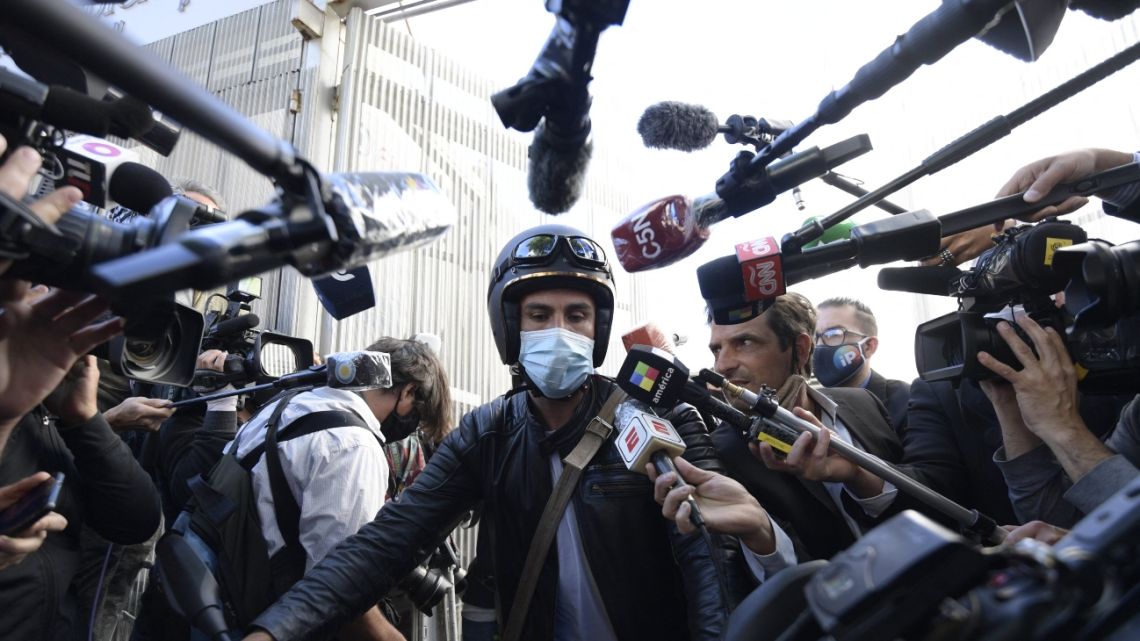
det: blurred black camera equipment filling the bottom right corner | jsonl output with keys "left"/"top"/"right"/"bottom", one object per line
{"left": 725, "top": 469, "right": 1140, "bottom": 641}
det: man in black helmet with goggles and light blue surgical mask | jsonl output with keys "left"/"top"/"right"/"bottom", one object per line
{"left": 247, "top": 225, "right": 748, "bottom": 641}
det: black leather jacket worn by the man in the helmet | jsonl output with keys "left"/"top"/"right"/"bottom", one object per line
{"left": 254, "top": 376, "right": 747, "bottom": 641}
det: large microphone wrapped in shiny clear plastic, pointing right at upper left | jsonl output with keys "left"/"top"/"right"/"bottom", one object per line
{"left": 92, "top": 172, "right": 457, "bottom": 298}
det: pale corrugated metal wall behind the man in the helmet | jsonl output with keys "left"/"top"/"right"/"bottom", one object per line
{"left": 128, "top": 0, "right": 646, "bottom": 414}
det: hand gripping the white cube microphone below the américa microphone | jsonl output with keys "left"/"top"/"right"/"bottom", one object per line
{"left": 645, "top": 456, "right": 776, "bottom": 554}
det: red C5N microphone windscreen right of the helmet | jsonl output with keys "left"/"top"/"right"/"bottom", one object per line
{"left": 610, "top": 196, "right": 709, "bottom": 273}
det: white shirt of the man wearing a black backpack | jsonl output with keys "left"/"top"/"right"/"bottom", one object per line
{"left": 226, "top": 388, "right": 388, "bottom": 571}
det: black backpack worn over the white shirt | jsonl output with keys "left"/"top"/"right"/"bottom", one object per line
{"left": 157, "top": 392, "right": 367, "bottom": 633}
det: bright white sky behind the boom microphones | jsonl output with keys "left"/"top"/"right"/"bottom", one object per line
{"left": 393, "top": 0, "right": 1140, "bottom": 380}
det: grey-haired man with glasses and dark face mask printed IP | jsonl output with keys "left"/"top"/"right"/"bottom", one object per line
{"left": 812, "top": 298, "right": 911, "bottom": 438}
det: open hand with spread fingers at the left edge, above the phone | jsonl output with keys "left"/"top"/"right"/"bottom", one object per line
{"left": 0, "top": 290, "right": 123, "bottom": 444}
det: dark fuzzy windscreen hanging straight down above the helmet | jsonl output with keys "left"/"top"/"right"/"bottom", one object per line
{"left": 527, "top": 121, "right": 594, "bottom": 214}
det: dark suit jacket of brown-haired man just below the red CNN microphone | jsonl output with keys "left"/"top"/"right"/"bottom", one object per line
{"left": 713, "top": 388, "right": 903, "bottom": 561}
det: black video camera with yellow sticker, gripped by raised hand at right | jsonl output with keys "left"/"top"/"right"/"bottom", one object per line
{"left": 914, "top": 220, "right": 1140, "bottom": 393}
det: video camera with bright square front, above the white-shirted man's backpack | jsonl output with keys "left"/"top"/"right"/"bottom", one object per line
{"left": 194, "top": 277, "right": 314, "bottom": 390}
